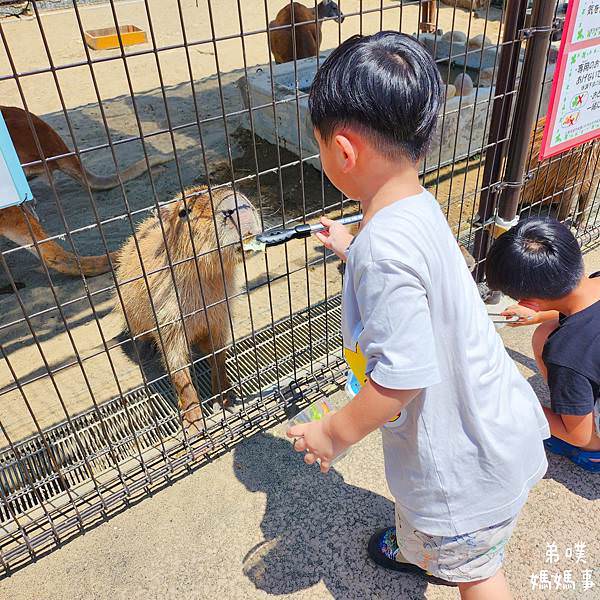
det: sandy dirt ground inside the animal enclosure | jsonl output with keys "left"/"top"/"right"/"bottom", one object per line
{"left": 0, "top": 0, "right": 499, "bottom": 446}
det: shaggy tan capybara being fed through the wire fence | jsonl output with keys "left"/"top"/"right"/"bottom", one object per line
{"left": 115, "top": 187, "right": 259, "bottom": 430}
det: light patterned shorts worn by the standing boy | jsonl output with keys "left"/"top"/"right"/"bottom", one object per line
{"left": 396, "top": 507, "right": 518, "bottom": 583}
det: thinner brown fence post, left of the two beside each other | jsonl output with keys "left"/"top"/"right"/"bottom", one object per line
{"left": 473, "top": 0, "right": 524, "bottom": 282}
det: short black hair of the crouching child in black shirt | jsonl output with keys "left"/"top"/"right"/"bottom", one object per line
{"left": 485, "top": 217, "right": 584, "bottom": 300}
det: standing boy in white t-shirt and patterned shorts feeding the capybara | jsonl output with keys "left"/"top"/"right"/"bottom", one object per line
{"left": 288, "top": 32, "right": 549, "bottom": 600}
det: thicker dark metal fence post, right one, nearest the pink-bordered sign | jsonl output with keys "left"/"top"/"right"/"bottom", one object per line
{"left": 498, "top": 0, "right": 556, "bottom": 224}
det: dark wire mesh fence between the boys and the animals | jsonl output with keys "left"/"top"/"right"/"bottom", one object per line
{"left": 0, "top": 0, "right": 599, "bottom": 572}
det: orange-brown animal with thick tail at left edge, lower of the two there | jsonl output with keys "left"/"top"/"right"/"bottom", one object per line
{"left": 0, "top": 205, "right": 115, "bottom": 277}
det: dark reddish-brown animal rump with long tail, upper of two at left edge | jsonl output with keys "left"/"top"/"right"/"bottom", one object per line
{"left": 0, "top": 106, "right": 170, "bottom": 190}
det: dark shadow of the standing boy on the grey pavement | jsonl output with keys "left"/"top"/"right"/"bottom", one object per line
{"left": 234, "top": 433, "right": 427, "bottom": 600}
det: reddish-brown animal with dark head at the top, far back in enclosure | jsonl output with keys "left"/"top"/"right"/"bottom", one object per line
{"left": 269, "top": 0, "right": 344, "bottom": 64}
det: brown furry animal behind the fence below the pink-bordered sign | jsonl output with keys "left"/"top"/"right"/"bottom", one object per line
{"left": 521, "top": 117, "right": 600, "bottom": 224}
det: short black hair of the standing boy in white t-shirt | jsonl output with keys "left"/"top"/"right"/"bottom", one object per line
{"left": 308, "top": 31, "right": 443, "bottom": 162}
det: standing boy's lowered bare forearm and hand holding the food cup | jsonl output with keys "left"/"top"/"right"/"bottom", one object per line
{"left": 287, "top": 379, "right": 421, "bottom": 473}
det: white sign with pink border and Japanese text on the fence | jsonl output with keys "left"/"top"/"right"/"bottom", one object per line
{"left": 540, "top": 0, "right": 600, "bottom": 160}
